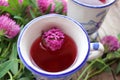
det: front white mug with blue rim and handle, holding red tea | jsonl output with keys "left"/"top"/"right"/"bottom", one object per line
{"left": 17, "top": 14, "right": 104, "bottom": 80}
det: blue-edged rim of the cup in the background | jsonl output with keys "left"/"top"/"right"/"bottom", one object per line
{"left": 72, "top": 0, "right": 116, "bottom": 8}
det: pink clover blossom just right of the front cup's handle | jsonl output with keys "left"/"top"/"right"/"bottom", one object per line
{"left": 101, "top": 36, "right": 120, "bottom": 52}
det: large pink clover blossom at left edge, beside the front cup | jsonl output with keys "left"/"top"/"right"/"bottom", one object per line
{"left": 0, "top": 15, "right": 20, "bottom": 38}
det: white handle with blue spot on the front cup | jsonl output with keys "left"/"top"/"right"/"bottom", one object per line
{"left": 88, "top": 42, "right": 104, "bottom": 61}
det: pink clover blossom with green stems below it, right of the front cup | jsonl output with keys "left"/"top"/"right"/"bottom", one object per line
{"left": 77, "top": 34, "right": 120, "bottom": 80}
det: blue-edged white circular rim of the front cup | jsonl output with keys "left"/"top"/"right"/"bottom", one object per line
{"left": 17, "top": 14, "right": 90, "bottom": 78}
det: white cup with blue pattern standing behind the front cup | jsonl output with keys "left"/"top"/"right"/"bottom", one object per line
{"left": 67, "top": 0, "right": 116, "bottom": 35}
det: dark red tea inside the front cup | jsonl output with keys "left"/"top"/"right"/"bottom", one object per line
{"left": 30, "top": 35, "right": 77, "bottom": 72}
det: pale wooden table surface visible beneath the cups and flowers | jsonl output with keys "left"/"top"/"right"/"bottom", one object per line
{"left": 72, "top": 1, "right": 120, "bottom": 80}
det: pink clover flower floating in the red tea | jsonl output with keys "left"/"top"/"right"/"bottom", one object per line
{"left": 42, "top": 28, "right": 65, "bottom": 51}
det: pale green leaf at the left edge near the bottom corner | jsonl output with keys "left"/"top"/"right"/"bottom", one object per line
{"left": 0, "top": 60, "right": 16, "bottom": 78}
